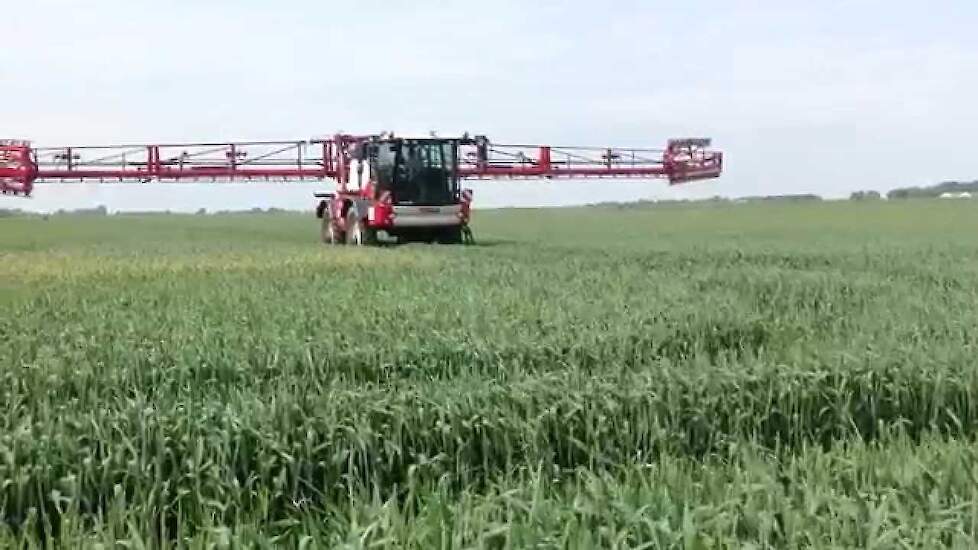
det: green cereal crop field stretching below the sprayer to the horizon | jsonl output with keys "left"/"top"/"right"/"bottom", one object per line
{"left": 0, "top": 201, "right": 978, "bottom": 548}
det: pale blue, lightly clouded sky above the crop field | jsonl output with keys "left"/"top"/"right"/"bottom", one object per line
{"left": 0, "top": 0, "right": 978, "bottom": 210}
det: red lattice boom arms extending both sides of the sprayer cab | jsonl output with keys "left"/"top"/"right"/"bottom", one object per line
{"left": 0, "top": 134, "right": 723, "bottom": 196}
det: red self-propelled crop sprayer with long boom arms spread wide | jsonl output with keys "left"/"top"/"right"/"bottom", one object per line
{"left": 0, "top": 133, "right": 723, "bottom": 245}
